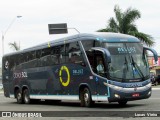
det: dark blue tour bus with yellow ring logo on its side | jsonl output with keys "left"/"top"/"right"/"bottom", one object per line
{"left": 2, "top": 33, "right": 158, "bottom": 107}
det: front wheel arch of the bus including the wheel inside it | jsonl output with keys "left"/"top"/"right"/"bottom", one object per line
{"left": 79, "top": 85, "right": 93, "bottom": 107}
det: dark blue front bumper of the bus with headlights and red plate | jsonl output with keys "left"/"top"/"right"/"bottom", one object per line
{"left": 104, "top": 83, "right": 152, "bottom": 102}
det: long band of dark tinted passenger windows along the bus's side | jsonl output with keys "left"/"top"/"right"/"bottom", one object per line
{"left": 8, "top": 42, "right": 84, "bottom": 69}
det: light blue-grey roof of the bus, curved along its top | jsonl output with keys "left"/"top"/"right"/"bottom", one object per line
{"left": 4, "top": 32, "right": 140, "bottom": 56}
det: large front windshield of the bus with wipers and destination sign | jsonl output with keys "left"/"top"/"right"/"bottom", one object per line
{"left": 104, "top": 43, "right": 149, "bottom": 82}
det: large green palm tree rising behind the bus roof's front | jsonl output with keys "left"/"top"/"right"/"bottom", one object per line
{"left": 98, "top": 5, "right": 154, "bottom": 46}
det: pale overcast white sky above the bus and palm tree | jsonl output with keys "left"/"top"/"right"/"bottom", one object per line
{"left": 0, "top": 0, "right": 160, "bottom": 65}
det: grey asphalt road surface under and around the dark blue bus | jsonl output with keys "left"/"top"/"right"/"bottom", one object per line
{"left": 0, "top": 89, "right": 160, "bottom": 120}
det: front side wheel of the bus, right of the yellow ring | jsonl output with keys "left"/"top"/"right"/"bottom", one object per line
{"left": 80, "top": 88, "right": 93, "bottom": 107}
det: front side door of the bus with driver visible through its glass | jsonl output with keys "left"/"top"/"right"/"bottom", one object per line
{"left": 92, "top": 48, "right": 110, "bottom": 101}
